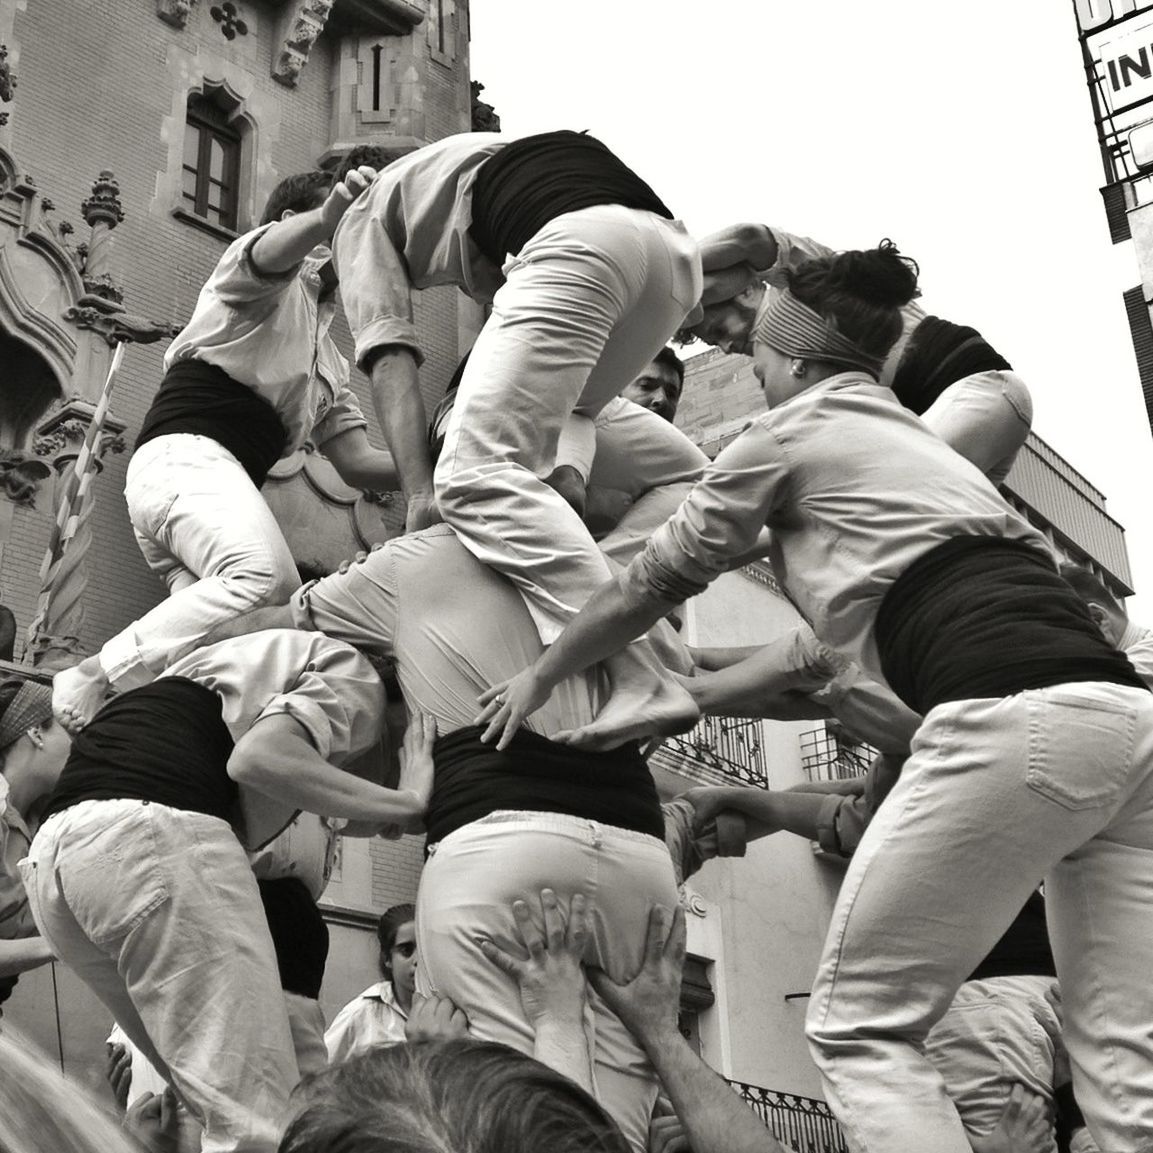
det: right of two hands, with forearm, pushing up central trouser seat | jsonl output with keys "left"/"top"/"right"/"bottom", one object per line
{"left": 589, "top": 905, "right": 785, "bottom": 1153}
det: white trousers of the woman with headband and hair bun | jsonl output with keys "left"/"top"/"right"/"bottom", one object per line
{"left": 807, "top": 683, "right": 1153, "bottom": 1153}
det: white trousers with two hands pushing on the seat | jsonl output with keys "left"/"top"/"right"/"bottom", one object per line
{"left": 416, "top": 812, "right": 677, "bottom": 1153}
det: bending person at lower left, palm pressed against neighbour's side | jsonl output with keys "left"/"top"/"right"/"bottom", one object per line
{"left": 21, "top": 631, "right": 435, "bottom": 1151}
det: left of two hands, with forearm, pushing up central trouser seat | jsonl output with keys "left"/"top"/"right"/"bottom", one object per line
{"left": 481, "top": 889, "right": 593, "bottom": 1093}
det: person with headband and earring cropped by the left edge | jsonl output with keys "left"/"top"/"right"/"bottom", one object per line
{"left": 0, "top": 677, "right": 69, "bottom": 1016}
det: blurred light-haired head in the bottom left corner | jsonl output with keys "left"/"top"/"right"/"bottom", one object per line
{"left": 0, "top": 1028, "right": 140, "bottom": 1153}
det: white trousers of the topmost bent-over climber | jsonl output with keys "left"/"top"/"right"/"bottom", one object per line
{"left": 435, "top": 204, "right": 701, "bottom": 643}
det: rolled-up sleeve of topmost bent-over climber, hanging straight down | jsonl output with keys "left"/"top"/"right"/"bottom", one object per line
{"left": 332, "top": 202, "right": 424, "bottom": 369}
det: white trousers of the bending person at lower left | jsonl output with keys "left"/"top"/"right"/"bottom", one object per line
{"left": 21, "top": 800, "right": 300, "bottom": 1153}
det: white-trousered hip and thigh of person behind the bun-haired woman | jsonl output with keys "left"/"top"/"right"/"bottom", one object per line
{"left": 921, "top": 370, "right": 1033, "bottom": 484}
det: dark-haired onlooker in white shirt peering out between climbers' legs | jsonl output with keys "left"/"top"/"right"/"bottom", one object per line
{"left": 324, "top": 904, "right": 416, "bottom": 1064}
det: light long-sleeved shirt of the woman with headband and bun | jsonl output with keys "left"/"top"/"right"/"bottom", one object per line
{"left": 625, "top": 372, "right": 1055, "bottom": 684}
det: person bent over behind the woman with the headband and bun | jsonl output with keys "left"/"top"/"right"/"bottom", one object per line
{"left": 685, "top": 224, "right": 1033, "bottom": 484}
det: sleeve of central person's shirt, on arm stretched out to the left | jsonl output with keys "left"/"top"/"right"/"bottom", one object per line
{"left": 289, "top": 544, "right": 399, "bottom": 656}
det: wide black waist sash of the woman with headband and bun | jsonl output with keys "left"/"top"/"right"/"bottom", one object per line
{"left": 874, "top": 536, "right": 1145, "bottom": 714}
